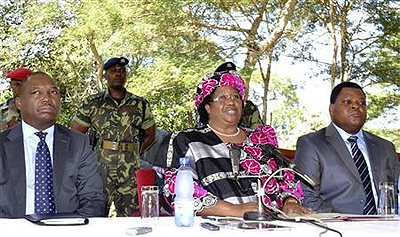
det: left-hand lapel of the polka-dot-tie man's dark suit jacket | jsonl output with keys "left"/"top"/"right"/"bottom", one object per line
{"left": 4, "top": 123, "right": 26, "bottom": 215}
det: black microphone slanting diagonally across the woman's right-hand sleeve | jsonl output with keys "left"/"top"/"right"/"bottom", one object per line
{"left": 262, "top": 144, "right": 315, "bottom": 190}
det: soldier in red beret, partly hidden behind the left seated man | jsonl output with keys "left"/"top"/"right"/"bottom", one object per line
{"left": 0, "top": 68, "right": 32, "bottom": 132}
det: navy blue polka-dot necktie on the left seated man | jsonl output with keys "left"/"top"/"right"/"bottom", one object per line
{"left": 35, "top": 132, "right": 56, "bottom": 214}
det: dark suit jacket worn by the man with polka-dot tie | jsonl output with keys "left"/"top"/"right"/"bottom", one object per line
{"left": 0, "top": 123, "right": 105, "bottom": 217}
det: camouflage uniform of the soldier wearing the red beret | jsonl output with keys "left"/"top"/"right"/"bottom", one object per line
{"left": 0, "top": 98, "right": 21, "bottom": 132}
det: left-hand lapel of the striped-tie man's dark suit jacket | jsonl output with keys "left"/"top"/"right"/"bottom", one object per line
{"left": 325, "top": 123, "right": 361, "bottom": 183}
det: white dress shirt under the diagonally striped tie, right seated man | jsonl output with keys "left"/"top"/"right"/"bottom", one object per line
{"left": 332, "top": 123, "right": 378, "bottom": 207}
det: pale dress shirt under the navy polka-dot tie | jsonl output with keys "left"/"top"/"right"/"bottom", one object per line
{"left": 22, "top": 121, "right": 54, "bottom": 214}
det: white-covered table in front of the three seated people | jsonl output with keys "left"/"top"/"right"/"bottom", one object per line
{"left": 0, "top": 217, "right": 400, "bottom": 237}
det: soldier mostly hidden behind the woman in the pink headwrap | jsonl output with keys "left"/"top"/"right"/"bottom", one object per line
{"left": 215, "top": 62, "right": 263, "bottom": 129}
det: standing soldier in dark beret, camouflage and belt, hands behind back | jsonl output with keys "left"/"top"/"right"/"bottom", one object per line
{"left": 71, "top": 57, "right": 156, "bottom": 216}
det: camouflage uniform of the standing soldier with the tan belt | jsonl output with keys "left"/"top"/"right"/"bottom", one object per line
{"left": 74, "top": 90, "right": 155, "bottom": 216}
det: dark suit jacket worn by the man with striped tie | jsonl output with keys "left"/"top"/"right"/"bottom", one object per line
{"left": 295, "top": 124, "right": 399, "bottom": 214}
